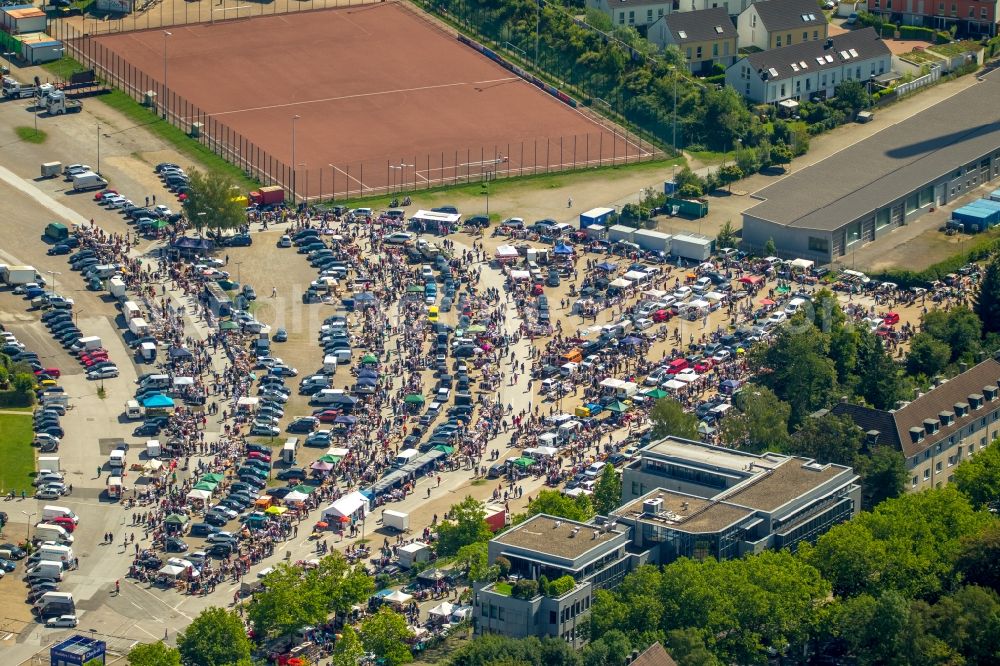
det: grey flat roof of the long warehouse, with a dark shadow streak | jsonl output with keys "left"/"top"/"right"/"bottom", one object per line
{"left": 744, "top": 71, "right": 1000, "bottom": 231}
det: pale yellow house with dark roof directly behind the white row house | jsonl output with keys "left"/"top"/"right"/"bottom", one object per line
{"left": 736, "top": 0, "right": 828, "bottom": 51}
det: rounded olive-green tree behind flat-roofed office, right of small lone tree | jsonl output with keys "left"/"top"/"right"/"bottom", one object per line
{"left": 720, "top": 386, "right": 791, "bottom": 452}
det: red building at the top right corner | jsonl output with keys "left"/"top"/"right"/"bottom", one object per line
{"left": 868, "top": 0, "right": 1000, "bottom": 37}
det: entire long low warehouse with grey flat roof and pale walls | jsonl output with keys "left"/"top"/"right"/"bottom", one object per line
{"left": 743, "top": 71, "right": 1000, "bottom": 263}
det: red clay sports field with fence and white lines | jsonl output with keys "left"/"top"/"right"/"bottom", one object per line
{"left": 88, "top": 2, "right": 649, "bottom": 197}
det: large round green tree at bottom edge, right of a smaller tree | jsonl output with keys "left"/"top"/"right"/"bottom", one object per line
{"left": 177, "top": 607, "right": 251, "bottom": 666}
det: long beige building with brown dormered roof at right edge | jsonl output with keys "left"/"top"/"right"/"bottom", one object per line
{"left": 830, "top": 357, "right": 1000, "bottom": 492}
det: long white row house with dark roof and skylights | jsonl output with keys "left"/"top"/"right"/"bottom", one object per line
{"left": 726, "top": 27, "right": 892, "bottom": 107}
